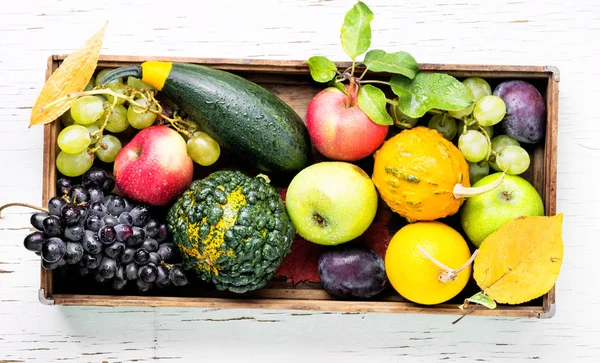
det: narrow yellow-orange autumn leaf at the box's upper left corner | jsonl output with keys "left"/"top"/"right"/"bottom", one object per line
{"left": 29, "top": 22, "right": 108, "bottom": 127}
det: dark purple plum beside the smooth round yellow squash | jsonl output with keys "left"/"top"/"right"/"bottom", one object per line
{"left": 319, "top": 247, "right": 388, "bottom": 299}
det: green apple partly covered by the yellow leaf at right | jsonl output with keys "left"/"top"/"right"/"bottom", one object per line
{"left": 460, "top": 173, "right": 544, "bottom": 247}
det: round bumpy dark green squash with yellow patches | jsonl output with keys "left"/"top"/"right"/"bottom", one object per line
{"left": 167, "top": 170, "right": 295, "bottom": 293}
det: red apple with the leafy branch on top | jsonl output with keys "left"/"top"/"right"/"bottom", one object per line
{"left": 306, "top": 87, "right": 389, "bottom": 161}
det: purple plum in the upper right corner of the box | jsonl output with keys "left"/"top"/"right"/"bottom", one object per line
{"left": 494, "top": 80, "right": 546, "bottom": 144}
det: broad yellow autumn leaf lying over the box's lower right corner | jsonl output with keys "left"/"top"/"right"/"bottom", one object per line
{"left": 473, "top": 214, "right": 564, "bottom": 304}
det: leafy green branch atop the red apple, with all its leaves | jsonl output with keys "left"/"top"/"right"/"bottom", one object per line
{"left": 307, "top": 1, "right": 473, "bottom": 125}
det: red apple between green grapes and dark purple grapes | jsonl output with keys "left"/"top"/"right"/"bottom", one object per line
{"left": 114, "top": 126, "right": 194, "bottom": 206}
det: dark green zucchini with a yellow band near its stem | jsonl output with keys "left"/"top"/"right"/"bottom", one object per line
{"left": 102, "top": 61, "right": 311, "bottom": 171}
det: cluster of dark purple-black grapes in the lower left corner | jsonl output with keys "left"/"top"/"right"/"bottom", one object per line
{"left": 24, "top": 167, "right": 188, "bottom": 292}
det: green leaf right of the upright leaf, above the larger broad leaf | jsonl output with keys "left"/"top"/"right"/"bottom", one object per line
{"left": 363, "top": 49, "right": 419, "bottom": 79}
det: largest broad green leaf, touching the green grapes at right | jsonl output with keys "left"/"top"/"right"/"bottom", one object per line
{"left": 390, "top": 72, "right": 473, "bottom": 118}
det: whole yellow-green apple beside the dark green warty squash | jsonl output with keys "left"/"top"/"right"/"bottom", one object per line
{"left": 285, "top": 161, "right": 377, "bottom": 245}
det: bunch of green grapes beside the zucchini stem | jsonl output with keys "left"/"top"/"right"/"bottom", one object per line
{"left": 56, "top": 69, "right": 220, "bottom": 177}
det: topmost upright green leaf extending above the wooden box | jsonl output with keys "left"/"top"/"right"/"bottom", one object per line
{"left": 340, "top": 1, "right": 374, "bottom": 61}
